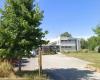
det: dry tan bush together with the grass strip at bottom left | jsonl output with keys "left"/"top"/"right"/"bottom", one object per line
{"left": 0, "top": 61, "right": 48, "bottom": 80}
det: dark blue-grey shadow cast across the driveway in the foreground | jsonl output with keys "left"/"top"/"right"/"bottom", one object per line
{"left": 44, "top": 68, "right": 96, "bottom": 80}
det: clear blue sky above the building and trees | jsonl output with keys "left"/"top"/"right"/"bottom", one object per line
{"left": 0, "top": 0, "right": 100, "bottom": 39}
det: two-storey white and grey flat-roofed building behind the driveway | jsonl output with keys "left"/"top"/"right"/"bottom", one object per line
{"left": 48, "top": 36, "right": 80, "bottom": 52}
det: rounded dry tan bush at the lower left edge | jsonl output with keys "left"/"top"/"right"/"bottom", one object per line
{"left": 0, "top": 61, "right": 13, "bottom": 77}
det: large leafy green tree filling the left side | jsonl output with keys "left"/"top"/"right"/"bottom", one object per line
{"left": 0, "top": 0, "right": 47, "bottom": 71}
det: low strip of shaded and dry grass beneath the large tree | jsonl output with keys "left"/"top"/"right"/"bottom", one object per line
{"left": 0, "top": 70, "right": 49, "bottom": 80}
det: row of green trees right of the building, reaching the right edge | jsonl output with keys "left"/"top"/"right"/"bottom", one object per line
{"left": 81, "top": 25, "right": 100, "bottom": 52}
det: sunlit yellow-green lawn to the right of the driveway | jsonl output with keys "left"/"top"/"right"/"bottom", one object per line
{"left": 64, "top": 52, "right": 100, "bottom": 68}
